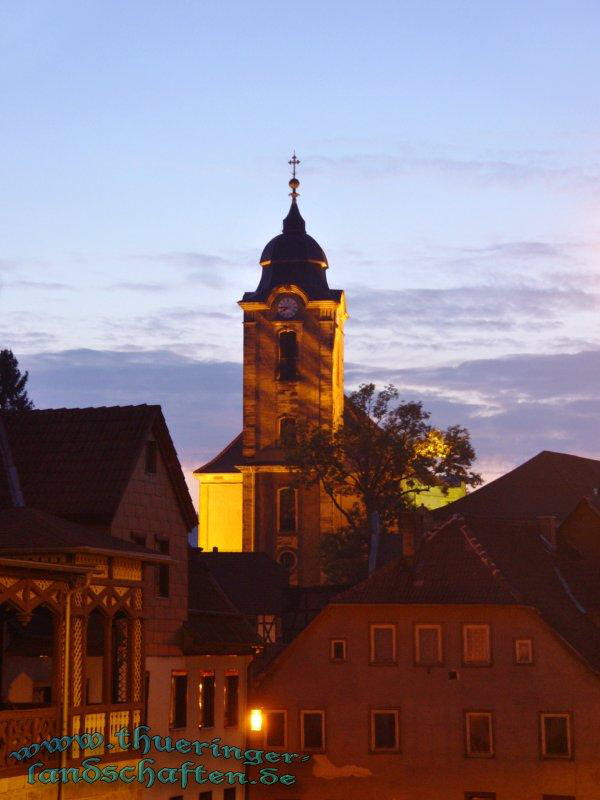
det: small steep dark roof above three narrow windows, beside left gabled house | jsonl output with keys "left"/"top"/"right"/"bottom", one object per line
{"left": 183, "top": 548, "right": 261, "bottom": 655}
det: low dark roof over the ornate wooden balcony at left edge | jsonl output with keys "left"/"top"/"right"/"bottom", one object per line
{"left": 0, "top": 508, "right": 162, "bottom": 561}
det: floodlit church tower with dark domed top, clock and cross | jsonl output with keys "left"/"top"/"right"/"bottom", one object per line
{"left": 195, "top": 155, "right": 347, "bottom": 584}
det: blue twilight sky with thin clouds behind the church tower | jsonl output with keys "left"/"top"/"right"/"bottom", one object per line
{"left": 0, "top": 0, "right": 600, "bottom": 500}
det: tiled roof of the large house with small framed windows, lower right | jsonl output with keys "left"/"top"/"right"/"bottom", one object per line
{"left": 332, "top": 516, "right": 600, "bottom": 670}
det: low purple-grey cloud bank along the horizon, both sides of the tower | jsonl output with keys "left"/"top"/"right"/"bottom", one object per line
{"left": 20, "top": 349, "right": 600, "bottom": 488}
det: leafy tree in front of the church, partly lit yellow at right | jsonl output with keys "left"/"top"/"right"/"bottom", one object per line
{"left": 284, "top": 383, "right": 481, "bottom": 582}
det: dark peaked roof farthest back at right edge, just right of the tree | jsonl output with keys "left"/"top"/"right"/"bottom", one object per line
{"left": 433, "top": 450, "right": 600, "bottom": 522}
